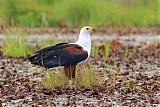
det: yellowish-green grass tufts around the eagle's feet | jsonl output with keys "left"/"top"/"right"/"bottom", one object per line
{"left": 40, "top": 65, "right": 103, "bottom": 89}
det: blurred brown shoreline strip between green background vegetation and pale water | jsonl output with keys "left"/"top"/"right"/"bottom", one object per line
{"left": 0, "top": 26, "right": 160, "bottom": 36}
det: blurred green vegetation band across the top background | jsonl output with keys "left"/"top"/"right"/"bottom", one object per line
{"left": 0, "top": 0, "right": 160, "bottom": 27}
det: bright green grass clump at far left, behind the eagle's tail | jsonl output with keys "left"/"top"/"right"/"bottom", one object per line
{"left": 2, "top": 30, "right": 34, "bottom": 57}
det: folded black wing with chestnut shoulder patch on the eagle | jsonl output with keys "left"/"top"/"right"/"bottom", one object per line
{"left": 28, "top": 43, "right": 88, "bottom": 68}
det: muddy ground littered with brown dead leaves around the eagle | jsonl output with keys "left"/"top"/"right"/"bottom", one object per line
{"left": 0, "top": 35, "right": 160, "bottom": 107}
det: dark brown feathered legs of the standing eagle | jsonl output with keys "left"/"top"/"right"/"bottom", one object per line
{"left": 64, "top": 65, "right": 76, "bottom": 79}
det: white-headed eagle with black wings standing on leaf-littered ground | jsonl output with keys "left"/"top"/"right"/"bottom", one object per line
{"left": 28, "top": 26, "right": 96, "bottom": 79}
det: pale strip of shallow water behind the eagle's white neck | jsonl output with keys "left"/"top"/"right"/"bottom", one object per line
{"left": 0, "top": 34, "right": 160, "bottom": 43}
